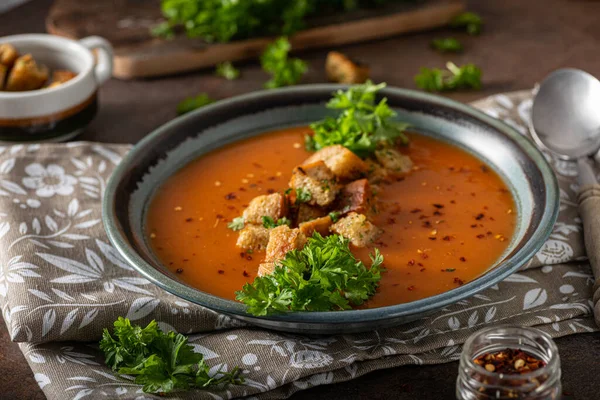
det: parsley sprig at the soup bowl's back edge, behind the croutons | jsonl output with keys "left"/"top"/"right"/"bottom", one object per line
{"left": 305, "top": 81, "right": 409, "bottom": 157}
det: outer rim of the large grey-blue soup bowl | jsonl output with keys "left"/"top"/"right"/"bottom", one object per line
{"left": 102, "top": 84, "right": 559, "bottom": 325}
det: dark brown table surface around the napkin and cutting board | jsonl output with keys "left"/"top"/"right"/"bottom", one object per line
{"left": 0, "top": 0, "right": 600, "bottom": 400}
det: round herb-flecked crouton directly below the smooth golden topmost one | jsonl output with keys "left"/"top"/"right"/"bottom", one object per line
{"left": 290, "top": 161, "right": 339, "bottom": 206}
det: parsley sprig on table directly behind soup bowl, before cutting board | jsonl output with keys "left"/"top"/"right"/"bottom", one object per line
{"left": 260, "top": 37, "right": 307, "bottom": 89}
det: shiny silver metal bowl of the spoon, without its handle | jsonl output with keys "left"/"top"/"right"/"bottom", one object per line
{"left": 531, "top": 69, "right": 600, "bottom": 160}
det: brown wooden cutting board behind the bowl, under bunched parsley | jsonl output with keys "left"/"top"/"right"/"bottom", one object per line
{"left": 46, "top": 0, "right": 465, "bottom": 79}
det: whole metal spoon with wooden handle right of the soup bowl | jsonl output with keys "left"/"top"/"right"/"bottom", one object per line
{"left": 531, "top": 69, "right": 600, "bottom": 326}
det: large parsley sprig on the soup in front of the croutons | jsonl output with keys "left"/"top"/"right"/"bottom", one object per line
{"left": 236, "top": 232, "right": 383, "bottom": 315}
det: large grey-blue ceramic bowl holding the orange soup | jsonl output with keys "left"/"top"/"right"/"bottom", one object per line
{"left": 103, "top": 85, "right": 559, "bottom": 334}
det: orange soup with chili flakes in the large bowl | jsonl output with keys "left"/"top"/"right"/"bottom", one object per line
{"left": 147, "top": 128, "right": 516, "bottom": 307}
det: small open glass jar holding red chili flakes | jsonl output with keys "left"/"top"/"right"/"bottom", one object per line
{"left": 456, "top": 326, "right": 562, "bottom": 400}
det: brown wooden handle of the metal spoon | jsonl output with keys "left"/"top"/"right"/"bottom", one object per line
{"left": 579, "top": 184, "right": 600, "bottom": 326}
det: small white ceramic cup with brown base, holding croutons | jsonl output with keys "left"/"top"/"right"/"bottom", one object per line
{"left": 0, "top": 34, "right": 113, "bottom": 142}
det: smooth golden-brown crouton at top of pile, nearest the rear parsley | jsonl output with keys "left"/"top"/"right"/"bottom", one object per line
{"left": 304, "top": 144, "right": 368, "bottom": 181}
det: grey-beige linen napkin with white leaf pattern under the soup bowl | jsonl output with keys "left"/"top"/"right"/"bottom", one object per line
{"left": 0, "top": 92, "right": 597, "bottom": 399}
